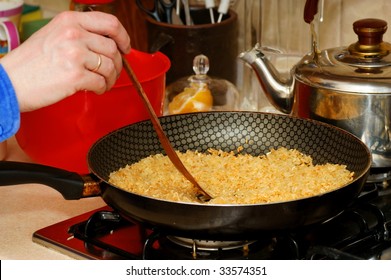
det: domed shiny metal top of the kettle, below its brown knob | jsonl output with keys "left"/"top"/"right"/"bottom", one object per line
{"left": 292, "top": 48, "right": 391, "bottom": 94}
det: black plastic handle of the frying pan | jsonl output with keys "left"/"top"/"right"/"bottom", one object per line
{"left": 0, "top": 161, "right": 84, "bottom": 200}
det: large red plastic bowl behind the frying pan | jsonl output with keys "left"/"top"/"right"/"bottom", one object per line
{"left": 16, "top": 50, "right": 170, "bottom": 174}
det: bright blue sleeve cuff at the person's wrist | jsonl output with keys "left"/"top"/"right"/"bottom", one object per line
{"left": 0, "top": 64, "right": 20, "bottom": 142}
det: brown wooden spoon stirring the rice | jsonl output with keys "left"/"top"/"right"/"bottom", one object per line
{"left": 122, "top": 55, "right": 211, "bottom": 202}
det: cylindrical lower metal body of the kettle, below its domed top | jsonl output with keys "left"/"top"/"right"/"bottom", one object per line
{"left": 291, "top": 83, "right": 391, "bottom": 167}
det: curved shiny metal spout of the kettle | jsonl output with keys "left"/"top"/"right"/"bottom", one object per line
{"left": 239, "top": 44, "right": 295, "bottom": 114}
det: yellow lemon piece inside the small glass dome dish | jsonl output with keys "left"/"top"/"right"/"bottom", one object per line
{"left": 168, "top": 83, "right": 213, "bottom": 114}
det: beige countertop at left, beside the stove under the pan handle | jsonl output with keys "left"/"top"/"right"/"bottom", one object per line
{"left": 0, "top": 138, "right": 106, "bottom": 260}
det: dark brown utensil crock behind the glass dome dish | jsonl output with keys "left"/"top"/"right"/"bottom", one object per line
{"left": 146, "top": 6, "right": 239, "bottom": 84}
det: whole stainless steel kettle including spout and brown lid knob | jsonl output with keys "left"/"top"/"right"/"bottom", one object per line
{"left": 239, "top": 19, "right": 391, "bottom": 171}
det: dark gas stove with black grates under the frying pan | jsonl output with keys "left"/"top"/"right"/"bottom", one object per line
{"left": 33, "top": 182, "right": 391, "bottom": 260}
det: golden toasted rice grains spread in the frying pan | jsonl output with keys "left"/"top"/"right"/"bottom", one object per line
{"left": 109, "top": 148, "right": 354, "bottom": 204}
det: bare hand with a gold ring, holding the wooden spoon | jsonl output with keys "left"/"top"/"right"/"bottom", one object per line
{"left": 0, "top": 11, "right": 130, "bottom": 112}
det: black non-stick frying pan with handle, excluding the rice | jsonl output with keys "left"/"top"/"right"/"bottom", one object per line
{"left": 0, "top": 112, "right": 371, "bottom": 240}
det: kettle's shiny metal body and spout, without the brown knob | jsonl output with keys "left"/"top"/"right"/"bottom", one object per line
{"left": 241, "top": 46, "right": 391, "bottom": 168}
